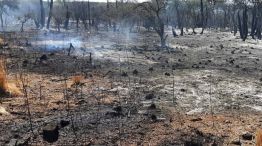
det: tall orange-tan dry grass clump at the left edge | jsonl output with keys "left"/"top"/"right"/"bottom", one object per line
{"left": 0, "top": 58, "right": 22, "bottom": 96}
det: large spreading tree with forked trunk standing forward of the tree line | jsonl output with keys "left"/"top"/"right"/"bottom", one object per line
{"left": 138, "top": 0, "right": 168, "bottom": 47}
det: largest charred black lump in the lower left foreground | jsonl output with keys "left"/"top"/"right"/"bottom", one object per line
{"left": 43, "top": 123, "right": 59, "bottom": 143}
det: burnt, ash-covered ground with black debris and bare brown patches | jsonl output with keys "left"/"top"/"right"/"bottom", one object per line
{"left": 0, "top": 30, "right": 262, "bottom": 146}
